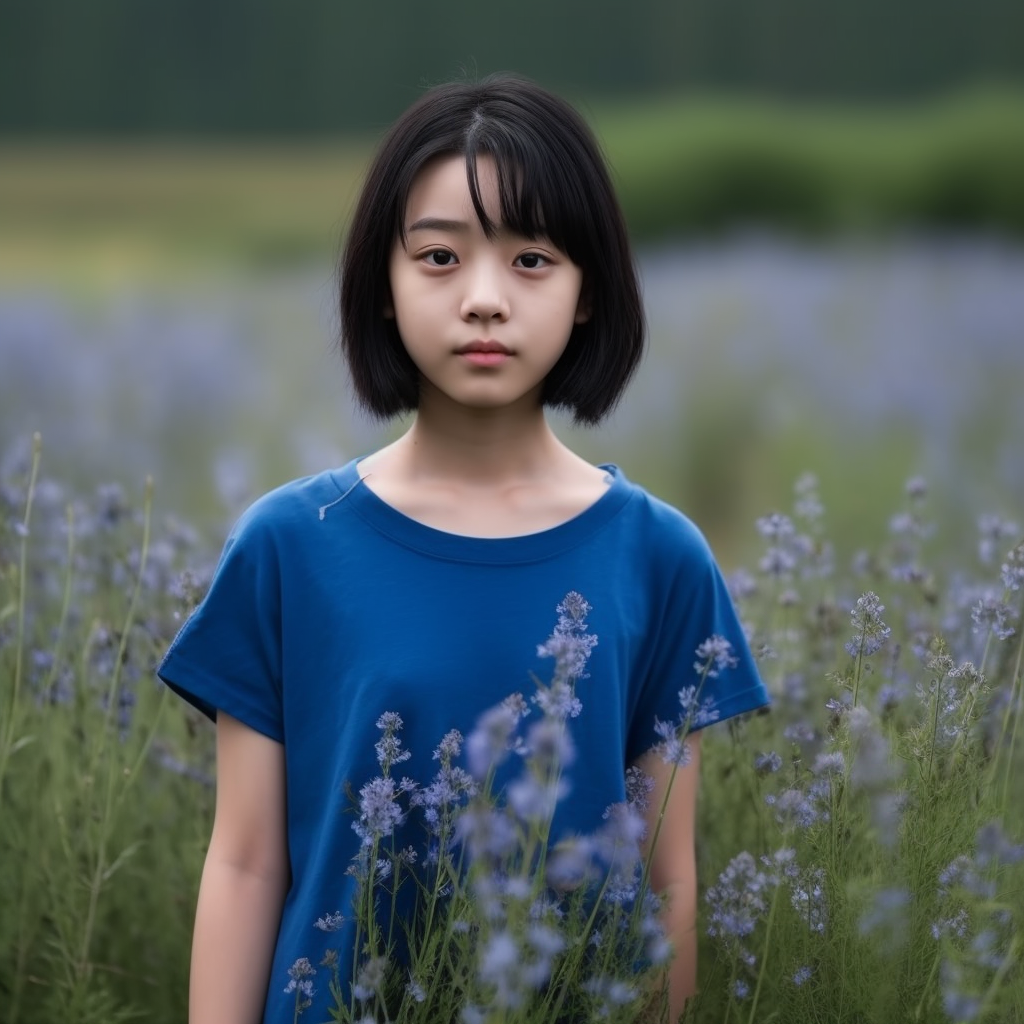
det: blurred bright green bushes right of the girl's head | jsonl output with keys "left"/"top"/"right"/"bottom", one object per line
{"left": 598, "top": 92, "right": 1024, "bottom": 240}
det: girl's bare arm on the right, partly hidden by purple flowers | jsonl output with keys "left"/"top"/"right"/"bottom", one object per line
{"left": 639, "top": 732, "right": 700, "bottom": 1021}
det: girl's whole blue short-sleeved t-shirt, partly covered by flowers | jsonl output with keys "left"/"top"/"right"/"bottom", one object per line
{"left": 159, "top": 461, "right": 768, "bottom": 1024}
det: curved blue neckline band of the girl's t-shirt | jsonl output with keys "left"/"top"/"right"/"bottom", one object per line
{"left": 331, "top": 456, "right": 633, "bottom": 562}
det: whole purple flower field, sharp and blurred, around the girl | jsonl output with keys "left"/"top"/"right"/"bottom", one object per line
{"left": 0, "top": 239, "right": 1024, "bottom": 1024}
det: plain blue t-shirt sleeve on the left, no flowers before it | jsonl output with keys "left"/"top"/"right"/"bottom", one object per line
{"left": 157, "top": 510, "right": 284, "bottom": 742}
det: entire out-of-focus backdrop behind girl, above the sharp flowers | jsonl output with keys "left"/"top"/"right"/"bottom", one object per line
{"left": 0, "top": 0, "right": 1024, "bottom": 563}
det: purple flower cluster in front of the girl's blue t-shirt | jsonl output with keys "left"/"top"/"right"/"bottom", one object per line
{"left": 299, "top": 592, "right": 736, "bottom": 1024}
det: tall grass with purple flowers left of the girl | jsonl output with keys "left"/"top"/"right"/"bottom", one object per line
{"left": 0, "top": 438, "right": 211, "bottom": 1024}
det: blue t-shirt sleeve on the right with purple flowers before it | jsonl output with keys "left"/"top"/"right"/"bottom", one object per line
{"left": 627, "top": 524, "right": 769, "bottom": 762}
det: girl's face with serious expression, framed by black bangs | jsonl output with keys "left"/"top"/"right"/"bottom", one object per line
{"left": 385, "top": 156, "right": 587, "bottom": 413}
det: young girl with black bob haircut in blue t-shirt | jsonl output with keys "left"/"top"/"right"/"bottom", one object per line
{"left": 160, "top": 77, "right": 767, "bottom": 1024}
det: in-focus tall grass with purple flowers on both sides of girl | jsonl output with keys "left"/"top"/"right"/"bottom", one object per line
{"left": 0, "top": 443, "right": 1024, "bottom": 1024}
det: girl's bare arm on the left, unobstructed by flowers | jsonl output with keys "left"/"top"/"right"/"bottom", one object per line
{"left": 188, "top": 712, "right": 289, "bottom": 1024}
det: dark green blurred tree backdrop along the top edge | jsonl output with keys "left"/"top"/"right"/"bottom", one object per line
{"left": 0, "top": 0, "right": 1024, "bottom": 136}
